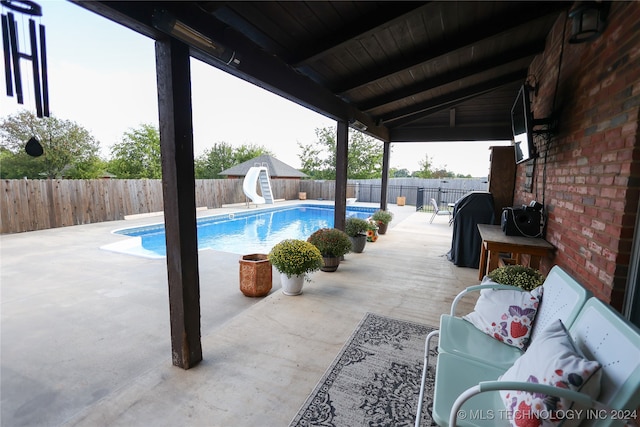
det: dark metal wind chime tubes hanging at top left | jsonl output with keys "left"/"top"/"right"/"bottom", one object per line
{"left": 0, "top": 0, "right": 49, "bottom": 118}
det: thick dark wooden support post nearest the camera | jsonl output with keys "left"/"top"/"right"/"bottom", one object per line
{"left": 156, "top": 39, "right": 202, "bottom": 369}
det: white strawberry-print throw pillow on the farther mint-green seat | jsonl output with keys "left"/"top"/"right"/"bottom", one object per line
{"left": 462, "top": 281, "right": 542, "bottom": 350}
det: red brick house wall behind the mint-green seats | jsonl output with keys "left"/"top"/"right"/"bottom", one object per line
{"left": 514, "top": 2, "right": 640, "bottom": 309}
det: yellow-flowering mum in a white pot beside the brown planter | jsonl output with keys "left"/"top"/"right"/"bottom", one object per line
{"left": 269, "top": 239, "right": 322, "bottom": 295}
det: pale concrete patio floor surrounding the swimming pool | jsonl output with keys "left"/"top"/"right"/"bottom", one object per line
{"left": 0, "top": 205, "right": 478, "bottom": 426}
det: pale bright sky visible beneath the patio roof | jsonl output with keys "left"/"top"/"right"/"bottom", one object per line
{"left": 0, "top": 0, "right": 510, "bottom": 177}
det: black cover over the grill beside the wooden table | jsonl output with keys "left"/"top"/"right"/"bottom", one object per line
{"left": 447, "top": 191, "right": 495, "bottom": 268}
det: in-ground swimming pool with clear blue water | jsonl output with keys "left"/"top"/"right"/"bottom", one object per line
{"left": 101, "top": 204, "right": 376, "bottom": 258}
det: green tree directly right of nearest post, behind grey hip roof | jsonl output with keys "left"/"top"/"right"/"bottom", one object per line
{"left": 195, "top": 142, "right": 273, "bottom": 179}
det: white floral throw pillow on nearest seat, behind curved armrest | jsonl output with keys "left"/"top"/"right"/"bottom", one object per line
{"left": 500, "top": 319, "right": 602, "bottom": 427}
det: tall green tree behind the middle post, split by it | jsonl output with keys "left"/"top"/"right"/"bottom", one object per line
{"left": 298, "top": 128, "right": 383, "bottom": 179}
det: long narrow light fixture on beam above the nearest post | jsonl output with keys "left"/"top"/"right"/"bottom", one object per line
{"left": 152, "top": 10, "right": 240, "bottom": 66}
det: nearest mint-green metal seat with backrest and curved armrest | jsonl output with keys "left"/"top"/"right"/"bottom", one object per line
{"left": 440, "top": 296, "right": 640, "bottom": 427}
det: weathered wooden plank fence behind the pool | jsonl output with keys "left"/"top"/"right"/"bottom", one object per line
{"left": 0, "top": 179, "right": 304, "bottom": 234}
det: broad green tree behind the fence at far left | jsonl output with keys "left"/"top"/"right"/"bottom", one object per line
{"left": 0, "top": 110, "right": 104, "bottom": 179}
